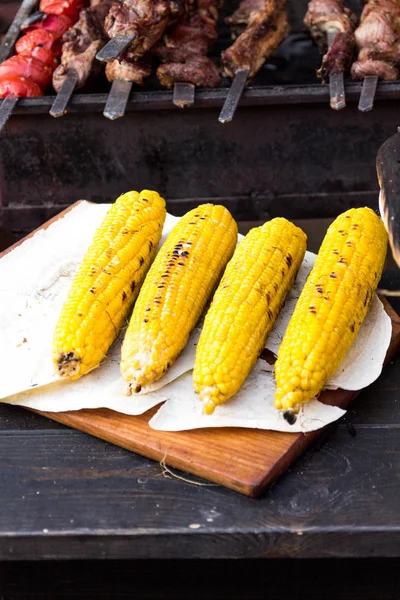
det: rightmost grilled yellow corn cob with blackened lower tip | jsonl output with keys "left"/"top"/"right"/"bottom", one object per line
{"left": 275, "top": 208, "right": 387, "bottom": 412}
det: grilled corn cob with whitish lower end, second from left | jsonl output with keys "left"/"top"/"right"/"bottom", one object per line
{"left": 121, "top": 204, "right": 237, "bottom": 394}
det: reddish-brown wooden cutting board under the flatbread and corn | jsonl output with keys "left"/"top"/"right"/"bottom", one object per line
{"left": 0, "top": 204, "right": 400, "bottom": 497}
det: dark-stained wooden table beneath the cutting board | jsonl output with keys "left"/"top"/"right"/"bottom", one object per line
{"left": 0, "top": 226, "right": 400, "bottom": 600}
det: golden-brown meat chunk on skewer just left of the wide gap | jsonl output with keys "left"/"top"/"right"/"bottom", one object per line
{"left": 222, "top": 6, "right": 289, "bottom": 79}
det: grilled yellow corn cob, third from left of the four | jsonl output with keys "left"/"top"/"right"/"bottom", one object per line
{"left": 193, "top": 219, "right": 307, "bottom": 414}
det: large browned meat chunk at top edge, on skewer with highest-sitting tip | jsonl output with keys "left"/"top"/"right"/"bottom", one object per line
{"left": 105, "top": 0, "right": 185, "bottom": 58}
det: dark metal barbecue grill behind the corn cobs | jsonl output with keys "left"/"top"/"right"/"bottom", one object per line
{"left": 0, "top": 0, "right": 400, "bottom": 241}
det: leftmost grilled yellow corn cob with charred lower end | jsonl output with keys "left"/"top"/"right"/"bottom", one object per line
{"left": 53, "top": 190, "right": 166, "bottom": 379}
